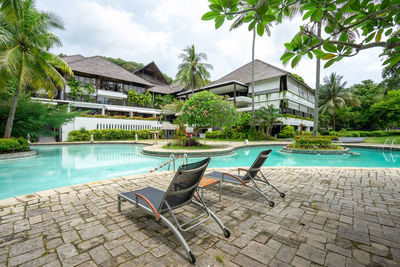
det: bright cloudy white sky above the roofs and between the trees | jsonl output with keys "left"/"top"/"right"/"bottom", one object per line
{"left": 37, "top": 0, "right": 382, "bottom": 86}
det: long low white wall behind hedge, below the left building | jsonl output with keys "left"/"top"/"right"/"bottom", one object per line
{"left": 61, "top": 117, "right": 170, "bottom": 142}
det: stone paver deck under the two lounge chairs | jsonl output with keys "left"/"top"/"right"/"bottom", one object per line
{"left": 0, "top": 167, "right": 400, "bottom": 267}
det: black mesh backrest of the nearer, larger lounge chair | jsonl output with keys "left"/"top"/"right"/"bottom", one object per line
{"left": 159, "top": 158, "right": 211, "bottom": 212}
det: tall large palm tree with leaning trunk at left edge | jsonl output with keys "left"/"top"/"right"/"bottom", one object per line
{"left": 0, "top": 0, "right": 73, "bottom": 138}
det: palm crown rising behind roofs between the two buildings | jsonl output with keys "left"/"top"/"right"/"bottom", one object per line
{"left": 176, "top": 45, "right": 213, "bottom": 93}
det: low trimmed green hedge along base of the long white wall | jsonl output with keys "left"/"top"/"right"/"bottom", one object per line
{"left": 67, "top": 129, "right": 155, "bottom": 142}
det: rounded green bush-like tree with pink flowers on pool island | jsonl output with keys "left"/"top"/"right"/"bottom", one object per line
{"left": 180, "top": 91, "right": 238, "bottom": 130}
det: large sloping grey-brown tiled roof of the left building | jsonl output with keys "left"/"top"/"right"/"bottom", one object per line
{"left": 63, "top": 55, "right": 152, "bottom": 86}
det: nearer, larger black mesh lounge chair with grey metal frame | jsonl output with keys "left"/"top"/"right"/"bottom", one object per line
{"left": 118, "top": 158, "right": 230, "bottom": 263}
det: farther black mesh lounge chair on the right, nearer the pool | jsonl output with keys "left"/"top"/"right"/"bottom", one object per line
{"left": 204, "top": 149, "right": 285, "bottom": 207}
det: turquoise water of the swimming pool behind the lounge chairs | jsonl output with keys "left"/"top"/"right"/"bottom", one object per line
{"left": 0, "top": 144, "right": 400, "bottom": 199}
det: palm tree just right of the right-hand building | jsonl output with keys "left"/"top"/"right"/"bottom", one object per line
{"left": 319, "top": 73, "right": 358, "bottom": 131}
